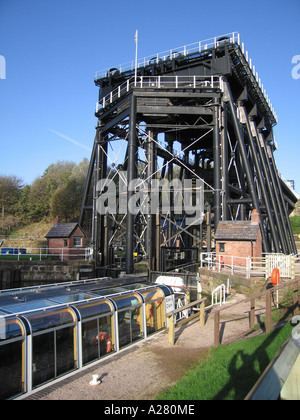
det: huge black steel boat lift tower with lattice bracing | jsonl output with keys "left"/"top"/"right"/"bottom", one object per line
{"left": 79, "top": 33, "right": 297, "bottom": 273}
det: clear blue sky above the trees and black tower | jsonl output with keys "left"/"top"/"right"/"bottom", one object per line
{"left": 0, "top": 0, "right": 300, "bottom": 194}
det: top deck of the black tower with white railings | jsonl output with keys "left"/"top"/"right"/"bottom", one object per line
{"left": 95, "top": 32, "right": 277, "bottom": 126}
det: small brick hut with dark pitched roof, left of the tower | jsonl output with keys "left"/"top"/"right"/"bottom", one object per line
{"left": 45, "top": 219, "right": 86, "bottom": 259}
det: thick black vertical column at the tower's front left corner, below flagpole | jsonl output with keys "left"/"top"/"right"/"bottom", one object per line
{"left": 126, "top": 94, "right": 137, "bottom": 274}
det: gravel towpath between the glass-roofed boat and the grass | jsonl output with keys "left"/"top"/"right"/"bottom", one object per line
{"left": 27, "top": 295, "right": 264, "bottom": 401}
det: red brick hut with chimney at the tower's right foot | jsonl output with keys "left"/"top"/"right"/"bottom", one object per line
{"left": 215, "top": 210, "right": 262, "bottom": 266}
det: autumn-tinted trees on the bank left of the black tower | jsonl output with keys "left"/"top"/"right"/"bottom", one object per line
{"left": 0, "top": 159, "right": 89, "bottom": 229}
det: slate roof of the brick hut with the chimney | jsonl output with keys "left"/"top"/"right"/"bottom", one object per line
{"left": 215, "top": 221, "right": 259, "bottom": 241}
